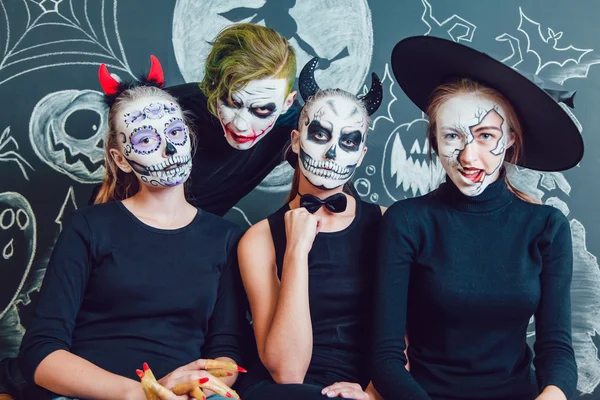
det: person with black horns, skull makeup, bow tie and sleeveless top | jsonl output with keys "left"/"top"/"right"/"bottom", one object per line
{"left": 238, "top": 59, "right": 382, "bottom": 400}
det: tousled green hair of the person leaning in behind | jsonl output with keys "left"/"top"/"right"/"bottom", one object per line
{"left": 199, "top": 23, "right": 296, "bottom": 116}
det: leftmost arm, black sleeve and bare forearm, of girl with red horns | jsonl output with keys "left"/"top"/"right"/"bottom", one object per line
{"left": 19, "top": 212, "right": 143, "bottom": 399}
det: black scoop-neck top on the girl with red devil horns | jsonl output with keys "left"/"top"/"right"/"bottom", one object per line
{"left": 19, "top": 202, "right": 245, "bottom": 398}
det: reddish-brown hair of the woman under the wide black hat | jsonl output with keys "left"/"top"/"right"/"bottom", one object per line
{"left": 426, "top": 78, "right": 539, "bottom": 204}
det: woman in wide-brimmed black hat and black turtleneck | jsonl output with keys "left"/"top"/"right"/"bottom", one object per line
{"left": 373, "top": 37, "right": 583, "bottom": 400}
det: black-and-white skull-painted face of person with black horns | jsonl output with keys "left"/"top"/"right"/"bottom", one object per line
{"left": 299, "top": 95, "right": 368, "bottom": 189}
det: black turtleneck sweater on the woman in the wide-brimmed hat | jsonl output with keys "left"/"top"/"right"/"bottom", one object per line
{"left": 372, "top": 177, "right": 577, "bottom": 400}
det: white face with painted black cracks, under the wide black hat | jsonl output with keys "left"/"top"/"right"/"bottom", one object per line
{"left": 436, "top": 93, "right": 513, "bottom": 196}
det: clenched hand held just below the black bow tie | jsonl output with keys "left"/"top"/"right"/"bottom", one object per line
{"left": 284, "top": 207, "right": 321, "bottom": 253}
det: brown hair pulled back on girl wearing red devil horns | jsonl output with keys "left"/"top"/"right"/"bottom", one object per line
{"left": 94, "top": 86, "right": 195, "bottom": 204}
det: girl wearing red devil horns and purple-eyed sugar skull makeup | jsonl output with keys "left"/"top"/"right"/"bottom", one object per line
{"left": 19, "top": 56, "right": 245, "bottom": 399}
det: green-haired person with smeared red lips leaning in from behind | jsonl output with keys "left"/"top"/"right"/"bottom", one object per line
{"left": 90, "top": 23, "right": 300, "bottom": 216}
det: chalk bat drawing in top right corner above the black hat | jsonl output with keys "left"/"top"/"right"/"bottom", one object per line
{"left": 496, "top": 7, "right": 600, "bottom": 85}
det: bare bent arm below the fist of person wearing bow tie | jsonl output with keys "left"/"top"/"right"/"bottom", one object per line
{"left": 238, "top": 209, "right": 314, "bottom": 383}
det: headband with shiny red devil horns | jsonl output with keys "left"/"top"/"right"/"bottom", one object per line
{"left": 98, "top": 55, "right": 165, "bottom": 107}
